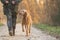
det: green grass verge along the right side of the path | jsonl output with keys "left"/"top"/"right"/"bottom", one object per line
{"left": 35, "top": 24, "right": 60, "bottom": 38}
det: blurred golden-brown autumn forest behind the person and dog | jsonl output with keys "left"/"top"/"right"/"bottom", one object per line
{"left": 0, "top": 0, "right": 60, "bottom": 25}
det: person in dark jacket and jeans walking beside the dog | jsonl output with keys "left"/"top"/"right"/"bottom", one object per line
{"left": 1, "top": 0, "right": 22, "bottom": 36}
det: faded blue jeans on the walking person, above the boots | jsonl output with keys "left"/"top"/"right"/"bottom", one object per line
{"left": 7, "top": 15, "right": 16, "bottom": 31}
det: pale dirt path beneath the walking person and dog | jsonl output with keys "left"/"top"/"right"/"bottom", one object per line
{"left": 0, "top": 24, "right": 57, "bottom": 40}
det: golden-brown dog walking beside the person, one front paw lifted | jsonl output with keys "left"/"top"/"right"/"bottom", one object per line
{"left": 19, "top": 10, "right": 32, "bottom": 36}
